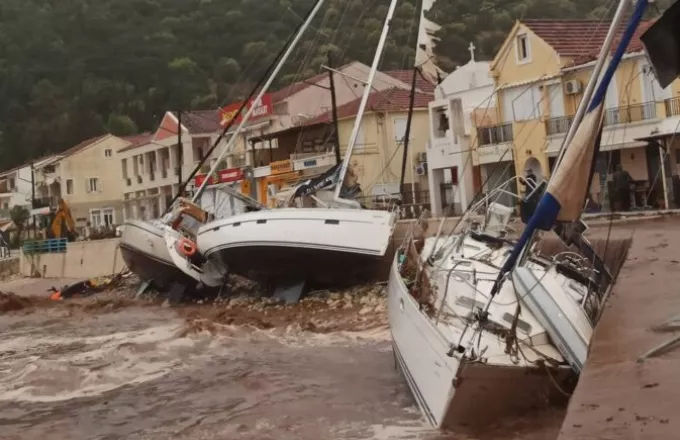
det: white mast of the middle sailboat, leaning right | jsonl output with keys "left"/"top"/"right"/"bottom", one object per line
{"left": 333, "top": 0, "right": 398, "bottom": 208}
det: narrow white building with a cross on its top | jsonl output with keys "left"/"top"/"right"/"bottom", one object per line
{"left": 427, "top": 44, "right": 496, "bottom": 217}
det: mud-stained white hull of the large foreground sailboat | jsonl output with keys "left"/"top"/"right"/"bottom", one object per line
{"left": 388, "top": 254, "right": 574, "bottom": 430}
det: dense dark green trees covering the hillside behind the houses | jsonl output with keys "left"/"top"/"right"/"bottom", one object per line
{"left": 0, "top": 0, "right": 668, "bottom": 168}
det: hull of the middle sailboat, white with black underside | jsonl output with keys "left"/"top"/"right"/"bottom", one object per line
{"left": 197, "top": 208, "right": 396, "bottom": 281}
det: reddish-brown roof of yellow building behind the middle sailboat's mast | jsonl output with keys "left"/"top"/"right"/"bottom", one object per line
{"left": 302, "top": 87, "right": 432, "bottom": 126}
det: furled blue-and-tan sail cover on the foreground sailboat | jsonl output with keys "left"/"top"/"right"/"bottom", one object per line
{"left": 501, "top": 0, "right": 648, "bottom": 276}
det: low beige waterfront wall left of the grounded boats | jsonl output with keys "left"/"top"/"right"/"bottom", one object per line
{"left": 20, "top": 239, "right": 125, "bottom": 279}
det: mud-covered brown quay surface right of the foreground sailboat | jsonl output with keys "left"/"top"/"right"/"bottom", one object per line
{"left": 558, "top": 219, "right": 680, "bottom": 440}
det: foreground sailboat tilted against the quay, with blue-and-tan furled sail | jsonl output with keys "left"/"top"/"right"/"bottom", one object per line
{"left": 388, "top": 0, "right": 677, "bottom": 430}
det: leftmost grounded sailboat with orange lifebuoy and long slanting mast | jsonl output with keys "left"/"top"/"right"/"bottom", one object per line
{"left": 120, "top": 0, "right": 324, "bottom": 290}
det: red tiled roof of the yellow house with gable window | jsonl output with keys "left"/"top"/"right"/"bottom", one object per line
{"left": 521, "top": 19, "right": 653, "bottom": 64}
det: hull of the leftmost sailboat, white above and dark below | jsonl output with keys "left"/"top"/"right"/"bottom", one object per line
{"left": 120, "top": 220, "right": 196, "bottom": 289}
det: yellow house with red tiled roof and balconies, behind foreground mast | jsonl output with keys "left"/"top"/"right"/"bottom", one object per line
{"left": 475, "top": 20, "right": 680, "bottom": 211}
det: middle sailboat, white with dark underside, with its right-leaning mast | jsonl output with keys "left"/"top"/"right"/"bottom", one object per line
{"left": 166, "top": 0, "right": 398, "bottom": 287}
